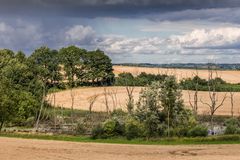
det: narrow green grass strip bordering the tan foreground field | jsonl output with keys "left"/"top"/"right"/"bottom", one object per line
{"left": 0, "top": 133, "right": 240, "bottom": 145}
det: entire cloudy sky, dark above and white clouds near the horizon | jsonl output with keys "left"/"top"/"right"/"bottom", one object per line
{"left": 0, "top": 0, "right": 240, "bottom": 63}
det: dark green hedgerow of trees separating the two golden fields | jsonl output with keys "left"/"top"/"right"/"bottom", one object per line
{"left": 115, "top": 72, "right": 240, "bottom": 92}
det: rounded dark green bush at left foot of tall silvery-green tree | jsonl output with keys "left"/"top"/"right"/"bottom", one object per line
{"left": 125, "top": 118, "right": 143, "bottom": 140}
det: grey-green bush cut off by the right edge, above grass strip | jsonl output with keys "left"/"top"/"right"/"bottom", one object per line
{"left": 224, "top": 118, "right": 240, "bottom": 134}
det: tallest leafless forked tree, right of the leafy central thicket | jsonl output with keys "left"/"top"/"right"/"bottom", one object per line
{"left": 201, "top": 66, "right": 227, "bottom": 132}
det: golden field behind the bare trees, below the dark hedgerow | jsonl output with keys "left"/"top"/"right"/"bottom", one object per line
{"left": 48, "top": 87, "right": 240, "bottom": 115}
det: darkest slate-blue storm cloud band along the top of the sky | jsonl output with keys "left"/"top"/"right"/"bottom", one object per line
{"left": 0, "top": 0, "right": 240, "bottom": 17}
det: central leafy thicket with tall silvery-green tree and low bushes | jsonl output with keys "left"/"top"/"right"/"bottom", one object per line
{"left": 92, "top": 76, "right": 208, "bottom": 139}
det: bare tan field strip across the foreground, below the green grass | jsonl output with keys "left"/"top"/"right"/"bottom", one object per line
{"left": 0, "top": 138, "right": 240, "bottom": 160}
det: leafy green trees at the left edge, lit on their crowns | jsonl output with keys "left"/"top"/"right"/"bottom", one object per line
{"left": 0, "top": 50, "right": 41, "bottom": 129}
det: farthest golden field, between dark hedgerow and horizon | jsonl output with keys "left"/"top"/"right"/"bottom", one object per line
{"left": 113, "top": 66, "right": 240, "bottom": 83}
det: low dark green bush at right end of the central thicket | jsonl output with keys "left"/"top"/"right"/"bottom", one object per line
{"left": 188, "top": 125, "right": 208, "bottom": 137}
